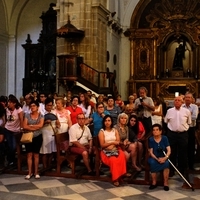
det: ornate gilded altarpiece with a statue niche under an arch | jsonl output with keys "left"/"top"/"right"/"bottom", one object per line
{"left": 126, "top": 0, "right": 200, "bottom": 99}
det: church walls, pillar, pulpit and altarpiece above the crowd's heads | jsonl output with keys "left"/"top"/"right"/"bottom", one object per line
{"left": 0, "top": 0, "right": 200, "bottom": 100}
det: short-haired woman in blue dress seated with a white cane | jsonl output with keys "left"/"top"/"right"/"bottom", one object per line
{"left": 148, "top": 124, "right": 171, "bottom": 191}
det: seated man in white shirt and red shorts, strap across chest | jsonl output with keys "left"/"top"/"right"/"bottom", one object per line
{"left": 69, "top": 113, "right": 95, "bottom": 175}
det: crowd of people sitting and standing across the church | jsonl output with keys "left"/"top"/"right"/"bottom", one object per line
{"left": 0, "top": 87, "right": 199, "bottom": 191}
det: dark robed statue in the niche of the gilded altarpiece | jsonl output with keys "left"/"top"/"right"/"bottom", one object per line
{"left": 172, "top": 41, "right": 186, "bottom": 70}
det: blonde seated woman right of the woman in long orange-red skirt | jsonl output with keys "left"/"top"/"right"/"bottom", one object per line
{"left": 114, "top": 113, "right": 141, "bottom": 172}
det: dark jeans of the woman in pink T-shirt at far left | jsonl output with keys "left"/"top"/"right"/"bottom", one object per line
{"left": 4, "top": 128, "right": 17, "bottom": 163}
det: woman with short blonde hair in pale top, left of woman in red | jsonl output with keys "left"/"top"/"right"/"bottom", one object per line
{"left": 54, "top": 98, "right": 72, "bottom": 133}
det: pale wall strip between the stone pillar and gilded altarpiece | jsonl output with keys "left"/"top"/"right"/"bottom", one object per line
{"left": 107, "top": 0, "right": 139, "bottom": 100}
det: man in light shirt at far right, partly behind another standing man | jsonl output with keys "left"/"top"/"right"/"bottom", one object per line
{"left": 183, "top": 92, "right": 199, "bottom": 170}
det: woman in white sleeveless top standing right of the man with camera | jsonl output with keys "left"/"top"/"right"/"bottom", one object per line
{"left": 151, "top": 98, "right": 163, "bottom": 126}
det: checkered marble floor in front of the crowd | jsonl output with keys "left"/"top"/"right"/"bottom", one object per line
{"left": 0, "top": 170, "right": 200, "bottom": 200}
